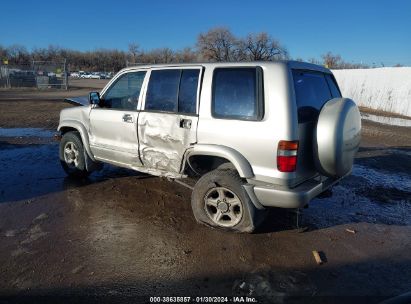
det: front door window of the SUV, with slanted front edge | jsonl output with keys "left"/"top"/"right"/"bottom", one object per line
{"left": 101, "top": 71, "right": 146, "bottom": 110}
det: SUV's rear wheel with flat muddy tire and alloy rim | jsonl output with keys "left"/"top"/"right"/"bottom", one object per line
{"left": 191, "top": 169, "right": 265, "bottom": 233}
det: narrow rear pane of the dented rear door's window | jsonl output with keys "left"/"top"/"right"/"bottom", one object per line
{"left": 178, "top": 69, "right": 200, "bottom": 114}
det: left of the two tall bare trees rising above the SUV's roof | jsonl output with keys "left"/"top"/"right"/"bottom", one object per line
{"left": 197, "top": 27, "right": 237, "bottom": 61}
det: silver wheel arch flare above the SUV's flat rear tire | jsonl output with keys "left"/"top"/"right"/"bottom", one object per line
{"left": 186, "top": 144, "right": 254, "bottom": 178}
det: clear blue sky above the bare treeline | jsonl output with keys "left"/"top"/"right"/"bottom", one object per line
{"left": 0, "top": 0, "right": 411, "bottom": 65}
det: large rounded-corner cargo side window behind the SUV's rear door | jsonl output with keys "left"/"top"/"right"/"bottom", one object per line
{"left": 212, "top": 68, "right": 263, "bottom": 120}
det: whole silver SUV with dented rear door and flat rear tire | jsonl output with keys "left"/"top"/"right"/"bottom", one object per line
{"left": 58, "top": 61, "right": 361, "bottom": 232}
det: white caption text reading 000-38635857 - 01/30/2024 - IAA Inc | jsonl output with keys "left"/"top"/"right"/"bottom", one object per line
{"left": 150, "top": 296, "right": 258, "bottom": 303}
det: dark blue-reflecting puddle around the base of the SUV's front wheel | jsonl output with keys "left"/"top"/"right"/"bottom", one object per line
{"left": 0, "top": 141, "right": 143, "bottom": 203}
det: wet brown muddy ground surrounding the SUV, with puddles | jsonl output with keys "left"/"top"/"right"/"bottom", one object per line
{"left": 0, "top": 88, "right": 411, "bottom": 303}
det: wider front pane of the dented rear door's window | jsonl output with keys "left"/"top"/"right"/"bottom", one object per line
{"left": 145, "top": 70, "right": 181, "bottom": 112}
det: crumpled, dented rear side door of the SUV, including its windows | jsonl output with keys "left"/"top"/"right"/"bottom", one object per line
{"left": 138, "top": 66, "right": 202, "bottom": 174}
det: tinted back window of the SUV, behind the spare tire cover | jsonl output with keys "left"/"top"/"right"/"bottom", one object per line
{"left": 293, "top": 70, "right": 340, "bottom": 123}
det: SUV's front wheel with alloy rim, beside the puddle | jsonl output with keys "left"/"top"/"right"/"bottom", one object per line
{"left": 59, "top": 132, "right": 90, "bottom": 178}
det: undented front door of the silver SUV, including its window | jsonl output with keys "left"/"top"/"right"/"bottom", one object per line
{"left": 90, "top": 71, "right": 146, "bottom": 167}
